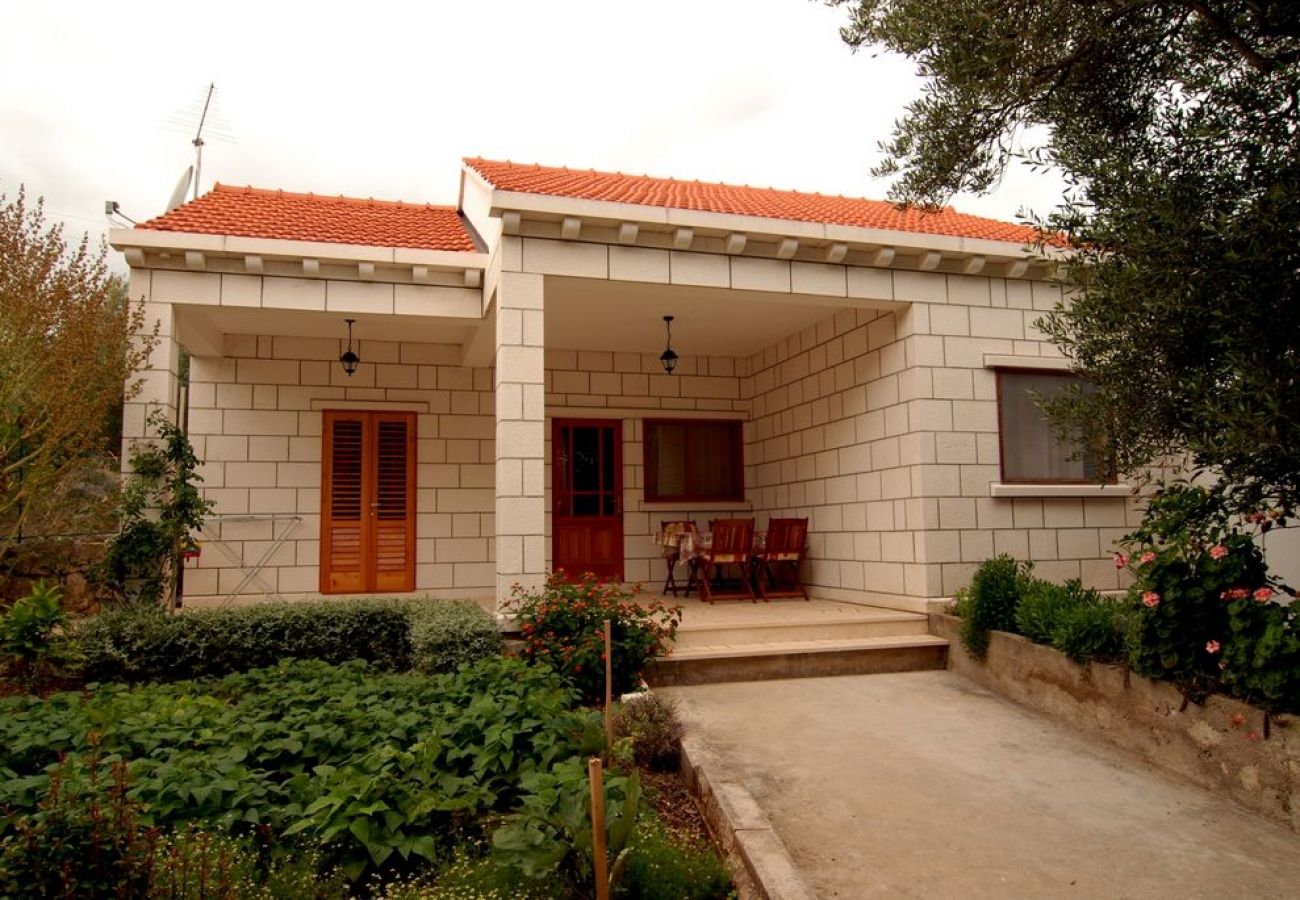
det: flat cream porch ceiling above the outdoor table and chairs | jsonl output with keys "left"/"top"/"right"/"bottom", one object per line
{"left": 546, "top": 276, "right": 902, "bottom": 356}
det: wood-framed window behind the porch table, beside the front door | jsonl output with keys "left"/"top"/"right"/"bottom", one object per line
{"left": 645, "top": 419, "right": 745, "bottom": 501}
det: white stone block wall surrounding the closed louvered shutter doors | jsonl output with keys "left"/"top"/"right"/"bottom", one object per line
{"left": 186, "top": 334, "right": 495, "bottom": 600}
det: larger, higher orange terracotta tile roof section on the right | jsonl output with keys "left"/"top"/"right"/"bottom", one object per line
{"left": 465, "top": 157, "right": 1036, "bottom": 245}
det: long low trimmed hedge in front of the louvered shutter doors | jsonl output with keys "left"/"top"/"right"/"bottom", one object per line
{"left": 75, "top": 600, "right": 411, "bottom": 682}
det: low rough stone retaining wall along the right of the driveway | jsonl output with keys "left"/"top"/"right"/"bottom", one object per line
{"left": 930, "top": 615, "right": 1300, "bottom": 831}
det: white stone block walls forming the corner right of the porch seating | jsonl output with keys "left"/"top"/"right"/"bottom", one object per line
{"left": 742, "top": 272, "right": 1138, "bottom": 602}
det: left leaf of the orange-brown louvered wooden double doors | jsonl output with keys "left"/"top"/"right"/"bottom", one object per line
{"left": 321, "top": 412, "right": 369, "bottom": 593}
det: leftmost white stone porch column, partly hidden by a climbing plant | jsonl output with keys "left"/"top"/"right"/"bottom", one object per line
{"left": 122, "top": 269, "right": 181, "bottom": 472}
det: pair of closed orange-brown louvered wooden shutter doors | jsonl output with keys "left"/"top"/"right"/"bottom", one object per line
{"left": 321, "top": 410, "right": 416, "bottom": 594}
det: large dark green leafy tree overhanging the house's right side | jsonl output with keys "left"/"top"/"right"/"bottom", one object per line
{"left": 829, "top": 0, "right": 1300, "bottom": 510}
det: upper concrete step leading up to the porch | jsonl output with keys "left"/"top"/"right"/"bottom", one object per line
{"left": 675, "top": 611, "right": 928, "bottom": 650}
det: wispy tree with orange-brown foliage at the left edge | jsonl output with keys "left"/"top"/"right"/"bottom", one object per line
{"left": 0, "top": 189, "right": 153, "bottom": 551}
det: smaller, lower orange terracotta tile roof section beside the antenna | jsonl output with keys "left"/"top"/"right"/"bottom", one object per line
{"left": 138, "top": 185, "right": 478, "bottom": 251}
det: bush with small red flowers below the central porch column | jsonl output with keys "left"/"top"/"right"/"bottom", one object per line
{"left": 508, "top": 571, "right": 681, "bottom": 702}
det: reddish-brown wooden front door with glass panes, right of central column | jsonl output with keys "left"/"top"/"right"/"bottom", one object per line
{"left": 551, "top": 419, "right": 623, "bottom": 581}
